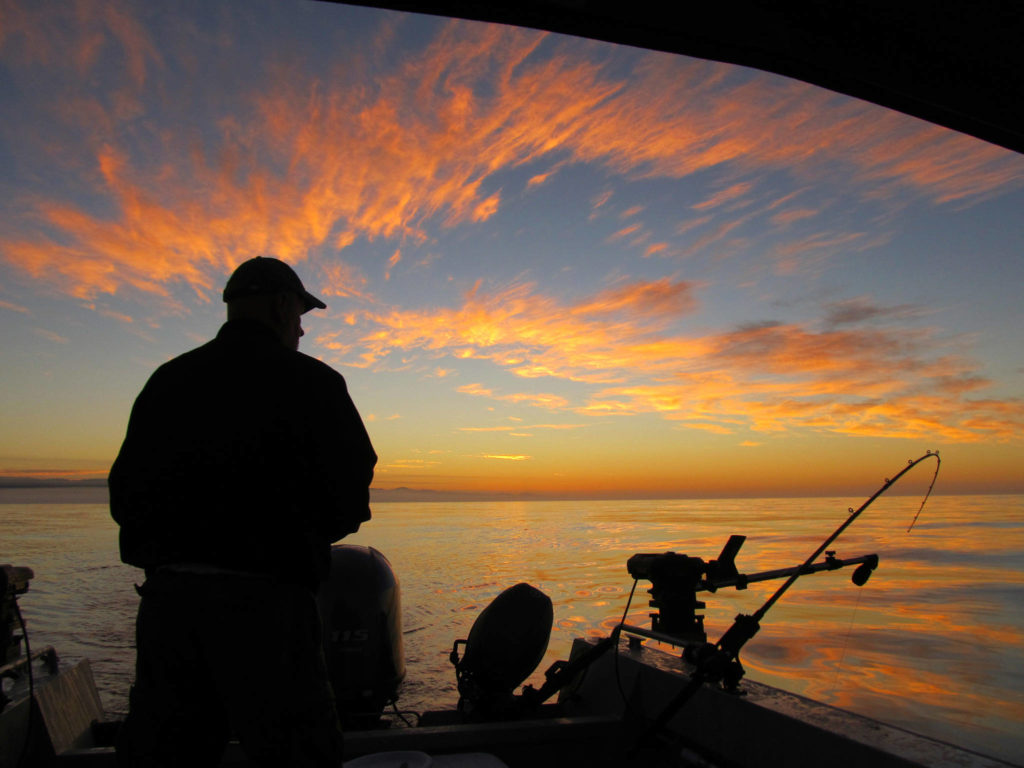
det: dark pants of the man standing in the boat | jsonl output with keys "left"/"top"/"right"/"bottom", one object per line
{"left": 118, "top": 570, "right": 342, "bottom": 768}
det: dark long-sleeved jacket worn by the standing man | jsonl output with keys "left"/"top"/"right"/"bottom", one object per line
{"left": 109, "top": 321, "right": 377, "bottom": 587}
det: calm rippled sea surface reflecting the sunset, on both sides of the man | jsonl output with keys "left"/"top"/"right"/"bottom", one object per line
{"left": 0, "top": 489, "right": 1024, "bottom": 764}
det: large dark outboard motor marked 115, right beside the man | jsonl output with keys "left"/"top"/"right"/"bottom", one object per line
{"left": 317, "top": 544, "right": 406, "bottom": 729}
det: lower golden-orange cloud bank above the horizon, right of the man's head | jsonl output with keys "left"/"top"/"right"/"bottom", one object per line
{"left": 361, "top": 281, "right": 1024, "bottom": 442}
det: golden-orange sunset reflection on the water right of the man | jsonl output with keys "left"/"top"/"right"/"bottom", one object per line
{"left": 348, "top": 497, "right": 1024, "bottom": 761}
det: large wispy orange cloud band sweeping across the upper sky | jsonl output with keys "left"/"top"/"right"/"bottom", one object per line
{"left": 6, "top": 8, "right": 1024, "bottom": 306}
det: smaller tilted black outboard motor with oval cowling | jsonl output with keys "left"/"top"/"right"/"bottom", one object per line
{"left": 451, "top": 584, "right": 554, "bottom": 720}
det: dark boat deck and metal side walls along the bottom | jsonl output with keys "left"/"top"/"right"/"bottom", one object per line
{"left": 0, "top": 640, "right": 1010, "bottom": 768}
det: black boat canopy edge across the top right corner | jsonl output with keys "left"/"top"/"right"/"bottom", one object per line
{"left": 328, "top": 0, "right": 1024, "bottom": 153}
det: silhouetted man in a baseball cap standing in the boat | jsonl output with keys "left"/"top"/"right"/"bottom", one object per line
{"left": 110, "top": 257, "right": 377, "bottom": 766}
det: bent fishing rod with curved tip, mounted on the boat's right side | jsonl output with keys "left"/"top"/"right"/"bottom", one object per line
{"left": 637, "top": 451, "right": 942, "bottom": 748}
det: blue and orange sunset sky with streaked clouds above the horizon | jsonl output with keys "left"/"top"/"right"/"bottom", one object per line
{"left": 0, "top": 0, "right": 1024, "bottom": 497}
